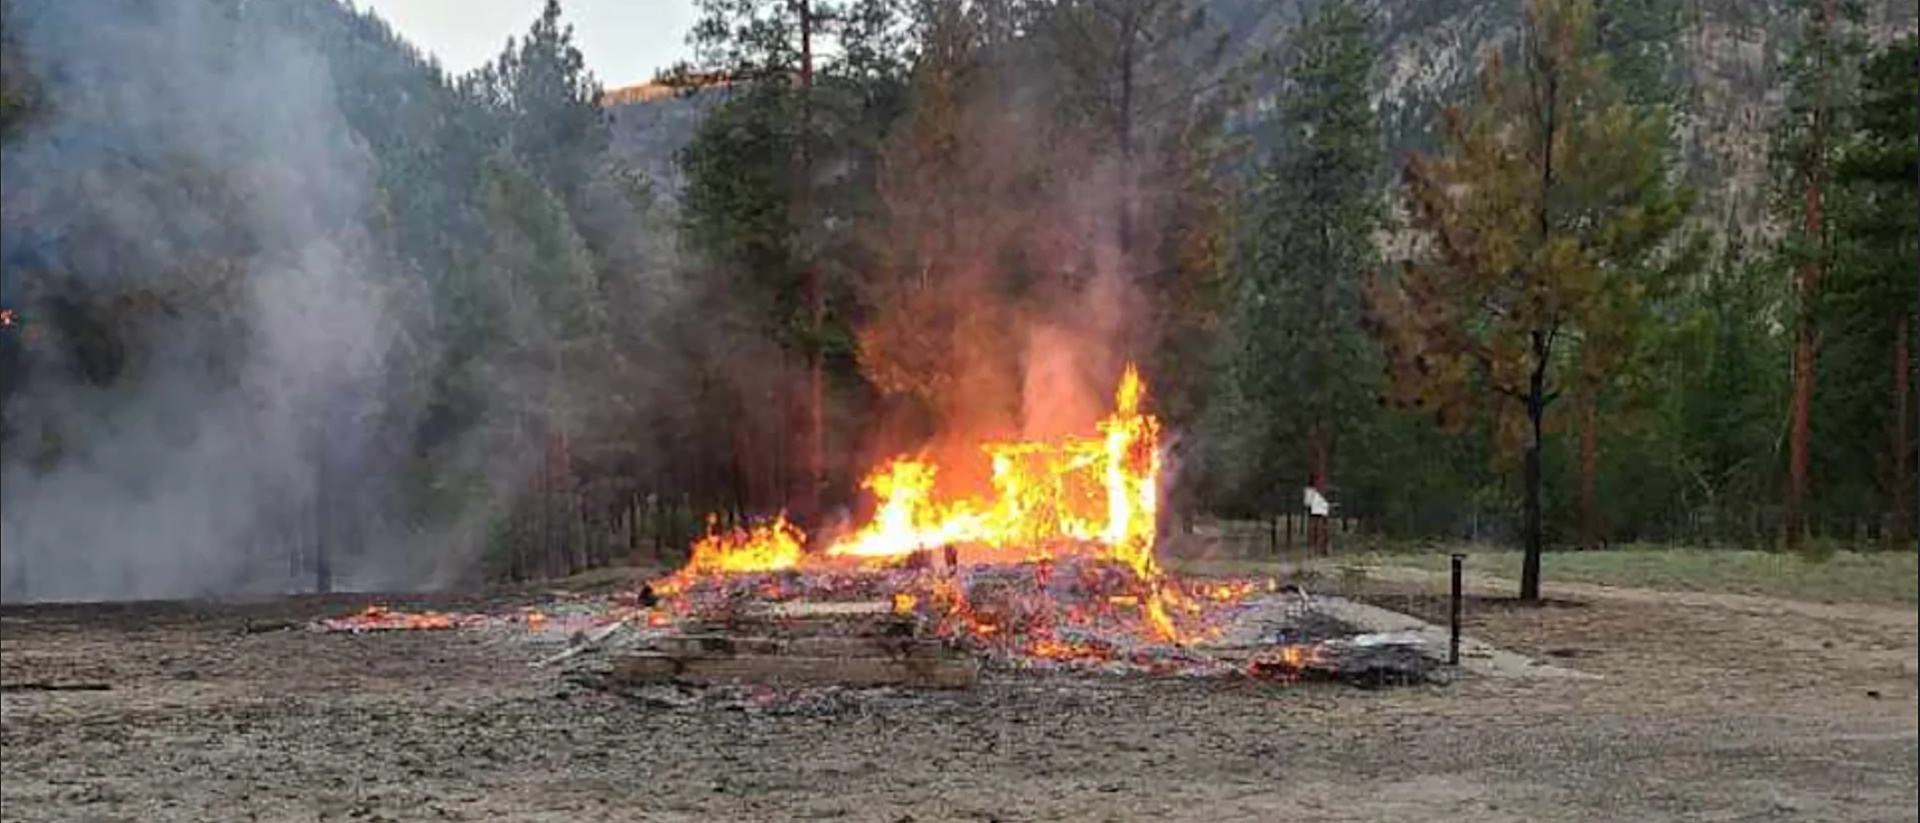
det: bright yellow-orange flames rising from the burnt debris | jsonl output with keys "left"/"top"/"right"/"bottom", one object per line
{"left": 657, "top": 364, "right": 1181, "bottom": 639}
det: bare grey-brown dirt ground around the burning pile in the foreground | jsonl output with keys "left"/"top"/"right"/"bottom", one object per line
{"left": 0, "top": 579, "right": 1920, "bottom": 821}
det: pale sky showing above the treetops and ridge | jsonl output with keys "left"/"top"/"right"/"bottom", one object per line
{"left": 359, "top": 0, "right": 695, "bottom": 88}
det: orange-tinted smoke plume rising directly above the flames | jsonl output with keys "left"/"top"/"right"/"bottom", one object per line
{"left": 862, "top": 48, "right": 1154, "bottom": 468}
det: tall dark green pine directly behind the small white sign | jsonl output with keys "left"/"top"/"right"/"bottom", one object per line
{"left": 1229, "top": 2, "right": 1382, "bottom": 533}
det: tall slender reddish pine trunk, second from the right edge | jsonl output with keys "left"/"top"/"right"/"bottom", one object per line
{"left": 1786, "top": 0, "right": 1836, "bottom": 549}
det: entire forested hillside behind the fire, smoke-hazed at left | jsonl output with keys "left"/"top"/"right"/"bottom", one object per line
{"left": 0, "top": 0, "right": 1920, "bottom": 599}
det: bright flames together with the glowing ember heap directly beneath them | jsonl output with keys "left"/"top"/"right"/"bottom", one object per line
{"left": 637, "top": 366, "right": 1256, "bottom": 668}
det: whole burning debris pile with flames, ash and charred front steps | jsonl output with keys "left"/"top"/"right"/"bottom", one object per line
{"left": 307, "top": 366, "right": 1427, "bottom": 689}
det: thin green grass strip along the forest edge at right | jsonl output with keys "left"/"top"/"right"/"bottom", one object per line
{"left": 1356, "top": 547, "right": 1920, "bottom": 606}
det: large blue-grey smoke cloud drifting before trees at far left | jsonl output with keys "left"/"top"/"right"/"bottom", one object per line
{"left": 0, "top": 2, "right": 396, "bottom": 600}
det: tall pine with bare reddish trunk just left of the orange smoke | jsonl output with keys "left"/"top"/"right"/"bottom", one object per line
{"left": 666, "top": 0, "right": 900, "bottom": 524}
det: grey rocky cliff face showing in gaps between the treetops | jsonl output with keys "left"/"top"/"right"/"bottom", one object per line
{"left": 609, "top": 0, "right": 1920, "bottom": 230}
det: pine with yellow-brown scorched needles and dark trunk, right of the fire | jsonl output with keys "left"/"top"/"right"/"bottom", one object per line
{"left": 1367, "top": 0, "right": 1688, "bottom": 600}
